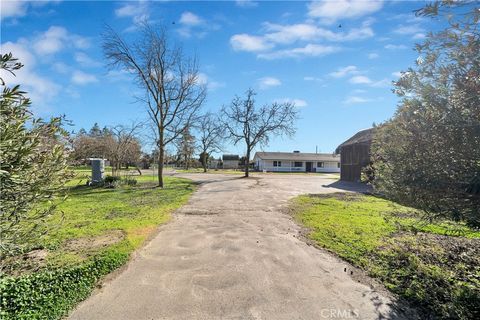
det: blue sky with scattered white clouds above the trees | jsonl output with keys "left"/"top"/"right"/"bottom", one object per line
{"left": 1, "top": 0, "right": 437, "bottom": 153}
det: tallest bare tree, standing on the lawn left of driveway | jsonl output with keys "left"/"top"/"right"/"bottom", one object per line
{"left": 103, "top": 22, "right": 206, "bottom": 187}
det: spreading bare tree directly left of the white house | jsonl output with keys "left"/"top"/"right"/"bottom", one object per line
{"left": 221, "top": 89, "right": 298, "bottom": 177}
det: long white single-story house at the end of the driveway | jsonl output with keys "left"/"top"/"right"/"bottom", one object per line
{"left": 253, "top": 151, "right": 340, "bottom": 172}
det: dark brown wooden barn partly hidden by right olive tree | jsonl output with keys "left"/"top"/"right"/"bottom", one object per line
{"left": 335, "top": 128, "right": 374, "bottom": 182}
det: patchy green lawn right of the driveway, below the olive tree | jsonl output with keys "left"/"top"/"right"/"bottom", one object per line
{"left": 290, "top": 194, "right": 480, "bottom": 319}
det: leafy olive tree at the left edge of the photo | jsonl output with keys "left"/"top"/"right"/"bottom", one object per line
{"left": 0, "top": 53, "right": 71, "bottom": 261}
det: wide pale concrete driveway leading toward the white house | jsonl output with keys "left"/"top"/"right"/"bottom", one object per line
{"left": 70, "top": 174, "right": 401, "bottom": 320}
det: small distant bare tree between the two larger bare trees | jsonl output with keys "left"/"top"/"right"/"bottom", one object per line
{"left": 198, "top": 113, "right": 223, "bottom": 172}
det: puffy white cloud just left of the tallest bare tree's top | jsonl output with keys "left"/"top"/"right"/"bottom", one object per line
{"left": 33, "top": 26, "right": 90, "bottom": 55}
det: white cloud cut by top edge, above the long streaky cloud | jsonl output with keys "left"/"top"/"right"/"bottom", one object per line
{"left": 308, "top": 0, "right": 383, "bottom": 23}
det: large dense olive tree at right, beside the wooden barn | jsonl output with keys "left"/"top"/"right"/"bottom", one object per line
{"left": 372, "top": 1, "right": 480, "bottom": 227}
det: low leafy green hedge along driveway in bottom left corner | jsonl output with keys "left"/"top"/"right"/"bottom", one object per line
{"left": 0, "top": 251, "right": 128, "bottom": 320}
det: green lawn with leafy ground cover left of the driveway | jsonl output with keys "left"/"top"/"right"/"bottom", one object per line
{"left": 0, "top": 169, "right": 195, "bottom": 319}
